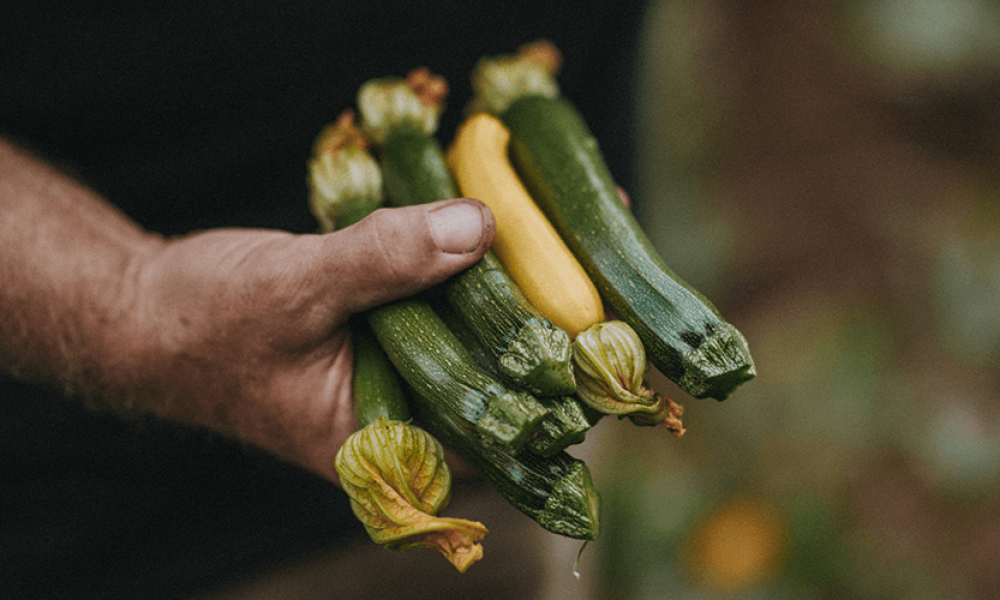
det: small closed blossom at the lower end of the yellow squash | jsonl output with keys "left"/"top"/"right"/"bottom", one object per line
{"left": 573, "top": 321, "right": 684, "bottom": 436}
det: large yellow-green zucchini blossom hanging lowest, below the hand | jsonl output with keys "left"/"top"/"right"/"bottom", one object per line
{"left": 336, "top": 416, "right": 487, "bottom": 573}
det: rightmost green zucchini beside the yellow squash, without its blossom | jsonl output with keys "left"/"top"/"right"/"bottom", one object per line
{"left": 500, "top": 95, "right": 756, "bottom": 400}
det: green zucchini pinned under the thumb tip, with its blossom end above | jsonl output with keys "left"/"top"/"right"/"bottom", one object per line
{"left": 358, "top": 79, "right": 576, "bottom": 396}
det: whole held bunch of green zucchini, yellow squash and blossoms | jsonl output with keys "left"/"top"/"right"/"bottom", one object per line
{"left": 309, "top": 45, "right": 754, "bottom": 570}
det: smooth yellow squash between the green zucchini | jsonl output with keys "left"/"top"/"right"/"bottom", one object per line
{"left": 448, "top": 113, "right": 604, "bottom": 337}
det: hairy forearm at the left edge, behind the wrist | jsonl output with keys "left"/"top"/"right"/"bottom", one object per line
{"left": 0, "top": 140, "right": 163, "bottom": 404}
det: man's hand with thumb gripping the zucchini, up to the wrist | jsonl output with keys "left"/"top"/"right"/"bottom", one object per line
{"left": 122, "top": 199, "right": 495, "bottom": 481}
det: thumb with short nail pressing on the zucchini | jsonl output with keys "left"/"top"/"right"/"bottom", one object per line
{"left": 324, "top": 198, "right": 496, "bottom": 313}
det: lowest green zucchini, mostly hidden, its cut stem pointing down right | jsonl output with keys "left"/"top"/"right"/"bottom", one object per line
{"left": 412, "top": 376, "right": 600, "bottom": 540}
